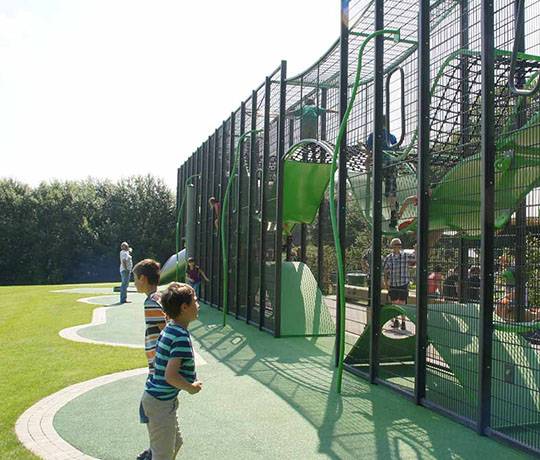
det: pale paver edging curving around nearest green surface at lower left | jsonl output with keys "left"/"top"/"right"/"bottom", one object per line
{"left": 15, "top": 367, "right": 148, "bottom": 460}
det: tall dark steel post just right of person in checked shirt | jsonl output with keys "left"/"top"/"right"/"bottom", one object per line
{"left": 414, "top": 0, "right": 431, "bottom": 404}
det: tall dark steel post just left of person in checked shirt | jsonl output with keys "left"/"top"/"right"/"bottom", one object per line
{"left": 369, "top": 0, "right": 384, "bottom": 383}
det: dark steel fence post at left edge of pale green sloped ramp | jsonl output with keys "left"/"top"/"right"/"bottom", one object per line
{"left": 274, "top": 61, "right": 287, "bottom": 337}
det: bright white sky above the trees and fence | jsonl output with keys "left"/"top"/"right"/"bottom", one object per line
{"left": 0, "top": 0, "right": 340, "bottom": 189}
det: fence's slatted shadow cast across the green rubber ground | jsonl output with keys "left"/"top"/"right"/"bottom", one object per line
{"left": 191, "top": 306, "right": 527, "bottom": 459}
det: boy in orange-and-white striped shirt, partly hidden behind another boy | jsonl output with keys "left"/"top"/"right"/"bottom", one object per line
{"left": 133, "top": 259, "right": 166, "bottom": 460}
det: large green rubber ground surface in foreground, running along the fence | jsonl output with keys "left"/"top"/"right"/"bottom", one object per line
{"left": 54, "top": 306, "right": 529, "bottom": 459}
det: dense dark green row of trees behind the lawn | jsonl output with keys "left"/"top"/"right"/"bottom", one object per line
{"left": 0, "top": 175, "right": 176, "bottom": 285}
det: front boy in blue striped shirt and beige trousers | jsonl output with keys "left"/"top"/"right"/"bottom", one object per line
{"left": 142, "top": 283, "right": 202, "bottom": 460}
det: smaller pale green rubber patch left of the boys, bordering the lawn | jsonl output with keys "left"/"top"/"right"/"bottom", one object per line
{"left": 78, "top": 294, "right": 145, "bottom": 347}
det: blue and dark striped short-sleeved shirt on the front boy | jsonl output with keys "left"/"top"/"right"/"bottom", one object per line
{"left": 145, "top": 322, "right": 197, "bottom": 400}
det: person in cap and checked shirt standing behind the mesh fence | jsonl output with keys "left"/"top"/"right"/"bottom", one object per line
{"left": 383, "top": 238, "right": 416, "bottom": 331}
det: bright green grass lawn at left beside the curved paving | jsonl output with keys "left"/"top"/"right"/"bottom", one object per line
{"left": 0, "top": 284, "right": 146, "bottom": 460}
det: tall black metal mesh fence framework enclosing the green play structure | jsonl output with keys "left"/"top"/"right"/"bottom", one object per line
{"left": 177, "top": 0, "right": 531, "bottom": 452}
